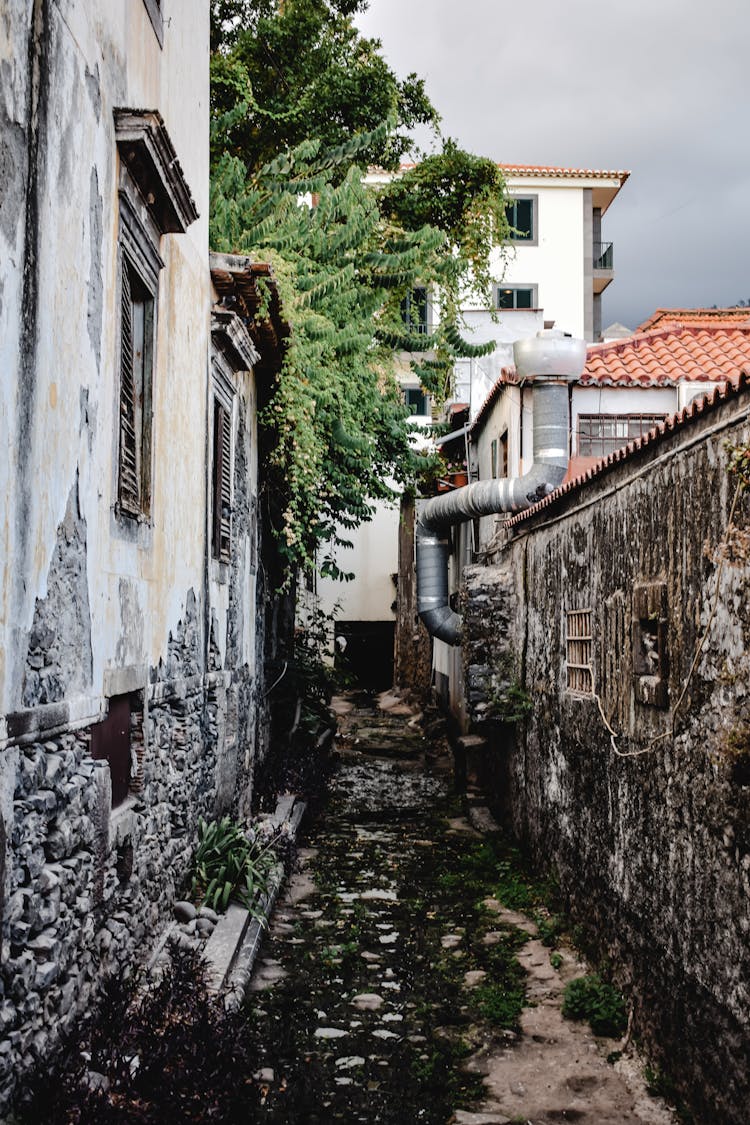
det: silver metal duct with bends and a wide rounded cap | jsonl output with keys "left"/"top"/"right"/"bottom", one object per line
{"left": 416, "top": 330, "right": 586, "bottom": 645}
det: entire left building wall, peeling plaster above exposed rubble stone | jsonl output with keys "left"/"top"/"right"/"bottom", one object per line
{"left": 0, "top": 0, "right": 270, "bottom": 1112}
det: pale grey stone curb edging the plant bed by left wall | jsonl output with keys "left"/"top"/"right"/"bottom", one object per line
{"left": 204, "top": 794, "right": 306, "bottom": 1009}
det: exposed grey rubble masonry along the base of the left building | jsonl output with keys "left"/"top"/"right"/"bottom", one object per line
{"left": 0, "top": 593, "right": 259, "bottom": 1107}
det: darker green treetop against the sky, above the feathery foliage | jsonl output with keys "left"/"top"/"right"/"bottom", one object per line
{"left": 211, "top": 0, "right": 439, "bottom": 168}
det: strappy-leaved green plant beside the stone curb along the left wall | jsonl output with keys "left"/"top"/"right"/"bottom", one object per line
{"left": 190, "top": 817, "right": 279, "bottom": 912}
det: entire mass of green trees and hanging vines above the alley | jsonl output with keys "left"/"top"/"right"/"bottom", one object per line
{"left": 210, "top": 0, "right": 506, "bottom": 573}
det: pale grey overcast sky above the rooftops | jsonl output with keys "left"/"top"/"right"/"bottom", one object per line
{"left": 358, "top": 0, "right": 750, "bottom": 329}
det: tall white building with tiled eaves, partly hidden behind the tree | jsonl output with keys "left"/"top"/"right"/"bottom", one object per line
{"left": 318, "top": 164, "right": 630, "bottom": 684}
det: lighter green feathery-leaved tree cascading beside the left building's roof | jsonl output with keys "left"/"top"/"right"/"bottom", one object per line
{"left": 210, "top": 126, "right": 444, "bottom": 572}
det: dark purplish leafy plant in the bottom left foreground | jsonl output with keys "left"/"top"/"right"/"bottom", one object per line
{"left": 17, "top": 951, "right": 262, "bottom": 1125}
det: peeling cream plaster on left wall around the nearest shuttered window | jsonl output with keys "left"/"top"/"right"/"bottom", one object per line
{"left": 0, "top": 0, "right": 209, "bottom": 711}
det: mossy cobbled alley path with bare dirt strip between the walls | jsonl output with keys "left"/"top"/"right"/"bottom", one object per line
{"left": 241, "top": 701, "right": 671, "bottom": 1125}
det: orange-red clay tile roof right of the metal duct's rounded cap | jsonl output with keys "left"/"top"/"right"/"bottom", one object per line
{"left": 580, "top": 324, "right": 750, "bottom": 387}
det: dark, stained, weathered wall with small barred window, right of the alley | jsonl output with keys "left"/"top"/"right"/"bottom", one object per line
{"left": 466, "top": 388, "right": 750, "bottom": 1125}
